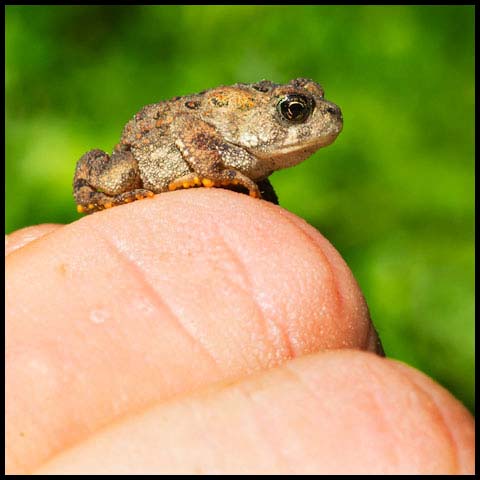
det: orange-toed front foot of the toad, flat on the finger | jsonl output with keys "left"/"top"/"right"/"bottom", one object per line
{"left": 168, "top": 168, "right": 261, "bottom": 198}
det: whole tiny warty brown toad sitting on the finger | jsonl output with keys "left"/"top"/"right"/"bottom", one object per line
{"left": 74, "top": 78, "right": 342, "bottom": 213}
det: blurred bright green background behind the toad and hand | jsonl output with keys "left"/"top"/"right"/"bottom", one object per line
{"left": 6, "top": 6, "right": 475, "bottom": 411}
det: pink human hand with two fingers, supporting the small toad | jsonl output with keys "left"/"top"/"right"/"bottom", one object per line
{"left": 6, "top": 189, "right": 474, "bottom": 474}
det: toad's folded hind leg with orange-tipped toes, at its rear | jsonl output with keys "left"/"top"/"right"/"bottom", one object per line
{"left": 73, "top": 149, "right": 153, "bottom": 213}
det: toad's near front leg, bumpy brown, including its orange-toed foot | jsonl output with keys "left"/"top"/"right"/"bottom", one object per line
{"left": 168, "top": 120, "right": 261, "bottom": 198}
